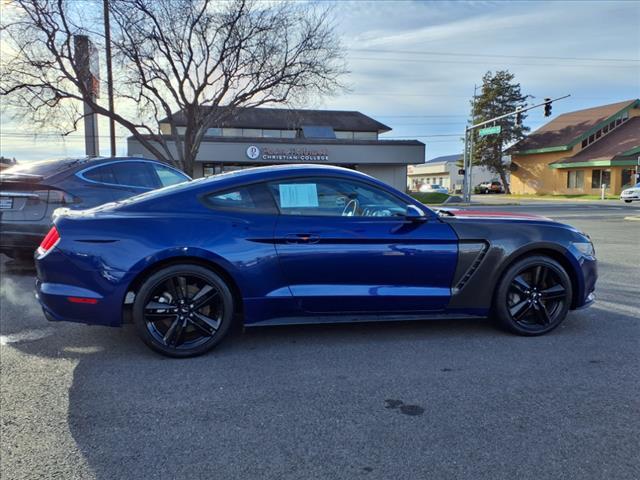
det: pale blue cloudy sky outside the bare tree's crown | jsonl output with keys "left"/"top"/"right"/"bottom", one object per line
{"left": 0, "top": 1, "right": 640, "bottom": 161}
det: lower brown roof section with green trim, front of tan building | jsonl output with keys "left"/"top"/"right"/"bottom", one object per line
{"left": 551, "top": 117, "right": 640, "bottom": 168}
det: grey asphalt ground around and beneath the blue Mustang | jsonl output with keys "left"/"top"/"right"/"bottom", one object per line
{"left": 0, "top": 202, "right": 640, "bottom": 480}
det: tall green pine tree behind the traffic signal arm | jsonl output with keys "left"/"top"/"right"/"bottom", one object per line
{"left": 470, "top": 70, "right": 531, "bottom": 193}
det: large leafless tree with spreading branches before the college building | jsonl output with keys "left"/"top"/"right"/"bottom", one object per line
{"left": 0, "top": 0, "right": 345, "bottom": 174}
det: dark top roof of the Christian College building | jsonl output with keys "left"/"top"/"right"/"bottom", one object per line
{"left": 160, "top": 107, "right": 391, "bottom": 133}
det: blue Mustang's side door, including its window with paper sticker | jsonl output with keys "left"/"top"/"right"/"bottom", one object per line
{"left": 269, "top": 177, "right": 457, "bottom": 314}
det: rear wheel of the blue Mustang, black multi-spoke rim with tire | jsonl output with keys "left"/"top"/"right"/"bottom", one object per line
{"left": 133, "top": 264, "right": 235, "bottom": 358}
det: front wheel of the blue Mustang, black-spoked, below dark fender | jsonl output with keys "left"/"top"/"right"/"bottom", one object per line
{"left": 494, "top": 255, "right": 573, "bottom": 336}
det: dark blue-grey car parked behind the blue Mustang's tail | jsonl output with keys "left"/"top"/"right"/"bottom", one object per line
{"left": 0, "top": 157, "right": 190, "bottom": 258}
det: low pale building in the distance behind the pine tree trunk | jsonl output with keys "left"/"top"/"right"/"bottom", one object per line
{"left": 407, "top": 154, "right": 498, "bottom": 192}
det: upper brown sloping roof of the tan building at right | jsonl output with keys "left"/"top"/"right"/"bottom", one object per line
{"left": 509, "top": 99, "right": 640, "bottom": 153}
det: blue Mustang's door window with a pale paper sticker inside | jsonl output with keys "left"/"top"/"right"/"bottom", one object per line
{"left": 269, "top": 178, "right": 407, "bottom": 217}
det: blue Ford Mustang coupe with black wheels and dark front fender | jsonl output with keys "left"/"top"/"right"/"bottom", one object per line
{"left": 36, "top": 165, "right": 597, "bottom": 357}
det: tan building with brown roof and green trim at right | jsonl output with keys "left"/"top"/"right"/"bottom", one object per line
{"left": 508, "top": 99, "right": 640, "bottom": 195}
